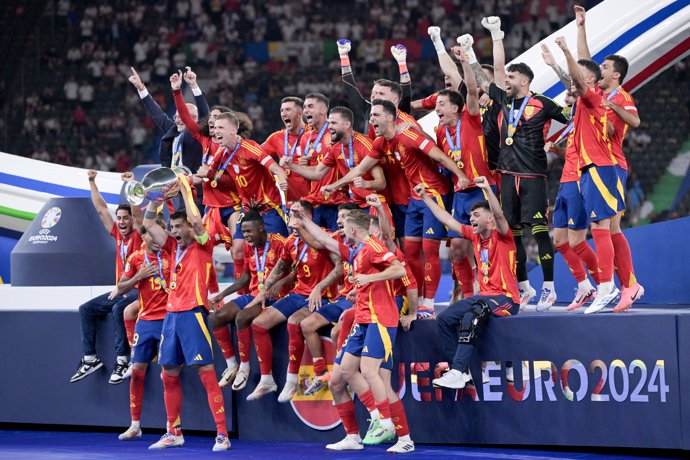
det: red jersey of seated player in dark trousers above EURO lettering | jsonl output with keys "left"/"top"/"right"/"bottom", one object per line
{"left": 462, "top": 225, "right": 520, "bottom": 303}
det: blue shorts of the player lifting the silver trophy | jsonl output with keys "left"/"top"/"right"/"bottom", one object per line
{"left": 158, "top": 307, "right": 213, "bottom": 366}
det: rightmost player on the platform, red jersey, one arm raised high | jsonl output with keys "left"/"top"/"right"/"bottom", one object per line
{"left": 575, "top": 6, "right": 644, "bottom": 313}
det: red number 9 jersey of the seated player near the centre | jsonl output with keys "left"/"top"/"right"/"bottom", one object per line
{"left": 280, "top": 234, "right": 338, "bottom": 300}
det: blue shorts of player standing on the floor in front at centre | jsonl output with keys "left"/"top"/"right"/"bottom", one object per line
{"left": 335, "top": 323, "right": 398, "bottom": 370}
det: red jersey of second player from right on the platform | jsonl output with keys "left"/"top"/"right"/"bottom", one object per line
{"left": 574, "top": 87, "right": 618, "bottom": 169}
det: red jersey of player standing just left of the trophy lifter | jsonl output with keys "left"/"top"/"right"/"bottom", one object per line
{"left": 124, "top": 249, "right": 170, "bottom": 321}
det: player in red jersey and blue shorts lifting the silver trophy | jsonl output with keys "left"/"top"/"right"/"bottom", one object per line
{"left": 144, "top": 177, "right": 230, "bottom": 451}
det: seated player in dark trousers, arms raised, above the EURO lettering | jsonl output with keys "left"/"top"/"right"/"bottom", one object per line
{"left": 415, "top": 177, "right": 520, "bottom": 389}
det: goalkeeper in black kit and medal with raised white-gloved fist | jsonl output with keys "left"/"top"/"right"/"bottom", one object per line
{"left": 458, "top": 35, "right": 569, "bottom": 309}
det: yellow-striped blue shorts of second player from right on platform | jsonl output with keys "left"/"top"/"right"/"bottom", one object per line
{"left": 580, "top": 165, "right": 620, "bottom": 222}
